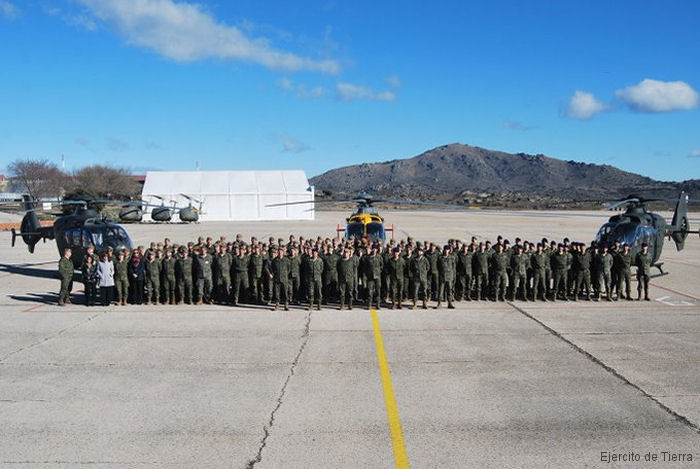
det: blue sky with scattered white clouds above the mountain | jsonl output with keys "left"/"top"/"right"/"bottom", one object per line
{"left": 0, "top": 0, "right": 700, "bottom": 180}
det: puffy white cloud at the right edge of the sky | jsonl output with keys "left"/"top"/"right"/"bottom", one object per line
{"left": 615, "top": 78, "right": 699, "bottom": 112}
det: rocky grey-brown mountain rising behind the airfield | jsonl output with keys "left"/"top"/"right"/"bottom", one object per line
{"left": 310, "top": 143, "right": 700, "bottom": 206}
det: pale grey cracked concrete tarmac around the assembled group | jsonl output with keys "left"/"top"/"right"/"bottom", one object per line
{"left": 0, "top": 212, "right": 700, "bottom": 468}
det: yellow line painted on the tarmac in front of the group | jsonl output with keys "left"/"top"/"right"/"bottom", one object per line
{"left": 371, "top": 309, "right": 410, "bottom": 469}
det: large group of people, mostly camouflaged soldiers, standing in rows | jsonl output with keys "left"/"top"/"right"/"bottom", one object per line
{"left": 59, "top": 235, "right": 652, "bottom": 310}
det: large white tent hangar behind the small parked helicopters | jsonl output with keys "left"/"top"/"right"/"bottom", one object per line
{"left": 142, "top": 170, "right": 314, "bottom": 221}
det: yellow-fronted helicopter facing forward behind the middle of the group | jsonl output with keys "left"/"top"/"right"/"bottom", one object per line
{"left": 267, "top": 193, "right": 473, "bottom": 241}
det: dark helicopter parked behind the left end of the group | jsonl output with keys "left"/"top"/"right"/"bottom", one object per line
{"left": 12, "top": 195, "right": 132, "bottom": 268}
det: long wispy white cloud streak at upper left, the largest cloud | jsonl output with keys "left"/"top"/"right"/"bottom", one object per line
{"left": 76, "top": 0, "right": 340, "bottom": 74}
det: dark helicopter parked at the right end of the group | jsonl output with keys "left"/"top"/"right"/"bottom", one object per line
{"left": 595, "top": 192, "right": 700, "bottom": 275}
